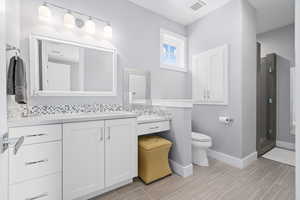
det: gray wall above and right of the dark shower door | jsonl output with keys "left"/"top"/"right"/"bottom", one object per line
{"left": 257, "top": 24, "right": 295, "bottom": 143}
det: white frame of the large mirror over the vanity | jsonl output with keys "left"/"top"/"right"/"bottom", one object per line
{"left": 29, "top": 34, "right": 118, "bottom": 97}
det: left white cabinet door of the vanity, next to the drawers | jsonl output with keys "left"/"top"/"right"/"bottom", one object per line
{"left": 63, "top": 121, "right": 105, "bottom": 200}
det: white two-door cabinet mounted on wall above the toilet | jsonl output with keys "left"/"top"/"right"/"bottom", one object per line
{"left": 192, "top": 45, "right": 228, "bottom": 105}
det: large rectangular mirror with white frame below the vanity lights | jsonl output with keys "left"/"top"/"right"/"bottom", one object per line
{"left": 30, "top": 36, "right": 117, "bottom": 96}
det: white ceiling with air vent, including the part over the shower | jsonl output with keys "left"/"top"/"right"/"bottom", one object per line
{"left": 129, "top": 0, "right": 295, "bottom": 33}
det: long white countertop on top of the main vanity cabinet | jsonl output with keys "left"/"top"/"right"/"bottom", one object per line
{"left": 8, "top": 112, "right": 137, "bottom": 128}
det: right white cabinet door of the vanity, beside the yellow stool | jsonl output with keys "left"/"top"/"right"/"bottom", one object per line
{"left": 105, "top": 119, "right": 137, "bottom": 187}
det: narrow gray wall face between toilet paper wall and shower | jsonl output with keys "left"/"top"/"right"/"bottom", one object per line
{"left": 241, "top": 1, "right": 257, "bottom": 157}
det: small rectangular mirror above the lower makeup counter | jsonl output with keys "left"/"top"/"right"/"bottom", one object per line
{"left": 123, "top": 68, "right": 151, "bottom": 105}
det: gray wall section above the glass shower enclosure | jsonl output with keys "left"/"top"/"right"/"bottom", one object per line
{"left": 257, "top": 24, "right": 295, "bottom": 65}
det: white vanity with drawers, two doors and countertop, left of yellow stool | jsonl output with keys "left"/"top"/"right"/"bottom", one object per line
{"left": 9, "top": 112, "right": 137, "bottom": 200}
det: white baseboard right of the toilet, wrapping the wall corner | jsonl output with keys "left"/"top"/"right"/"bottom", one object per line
{"left": 208, "top": 149, "right": 257, "bottom": 169}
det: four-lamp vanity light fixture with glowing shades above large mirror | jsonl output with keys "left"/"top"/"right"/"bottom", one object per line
{"left": 39, "top": 2, "right": 112, "bottom": 39}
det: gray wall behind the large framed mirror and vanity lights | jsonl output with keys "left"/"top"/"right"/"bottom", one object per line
{"left": 21, "top": 0, "right": 187, "bottom": 104}
